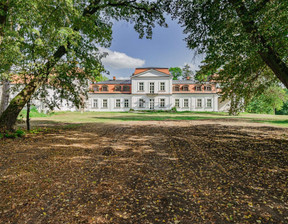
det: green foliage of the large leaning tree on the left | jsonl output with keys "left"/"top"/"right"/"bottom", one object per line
{"left": 0, "top": 0, "right": 167, "bottom": 128}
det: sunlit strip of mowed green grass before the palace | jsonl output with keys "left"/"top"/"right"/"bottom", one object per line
{"left": 33, "top": 112, "right": 288, "bottom": 127}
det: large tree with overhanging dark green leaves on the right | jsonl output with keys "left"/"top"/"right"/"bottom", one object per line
{"left": 162, "top": 0, "right": 288, "bottom": 111}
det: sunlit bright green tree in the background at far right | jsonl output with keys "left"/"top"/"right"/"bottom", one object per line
{"left": 247, "top": 85, "right": 288, "bottom": 114}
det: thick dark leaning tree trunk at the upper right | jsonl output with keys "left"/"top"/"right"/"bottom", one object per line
{"left": 229, "top": 0, "right": 288, "bottom": 88}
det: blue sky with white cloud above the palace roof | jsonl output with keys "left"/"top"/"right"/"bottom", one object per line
{"left": 100, "top": 18, "right": 203, "bottom": 79}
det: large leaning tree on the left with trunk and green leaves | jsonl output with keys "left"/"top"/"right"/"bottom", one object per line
{"left": 0, "top": 0, "right": 166, "bottom": 130}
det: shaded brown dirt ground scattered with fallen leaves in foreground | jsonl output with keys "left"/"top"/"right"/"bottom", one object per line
{"left": 0, "top": 120, "right": 288, "bottom": 224}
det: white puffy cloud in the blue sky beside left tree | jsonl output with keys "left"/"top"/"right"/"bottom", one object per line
{"left": 99, "top": 47, "right": 145, "bottom": 69}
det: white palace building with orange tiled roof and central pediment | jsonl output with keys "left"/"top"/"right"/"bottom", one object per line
{"left": 86, "top": 68, "right": 229, "bottom": 112}
